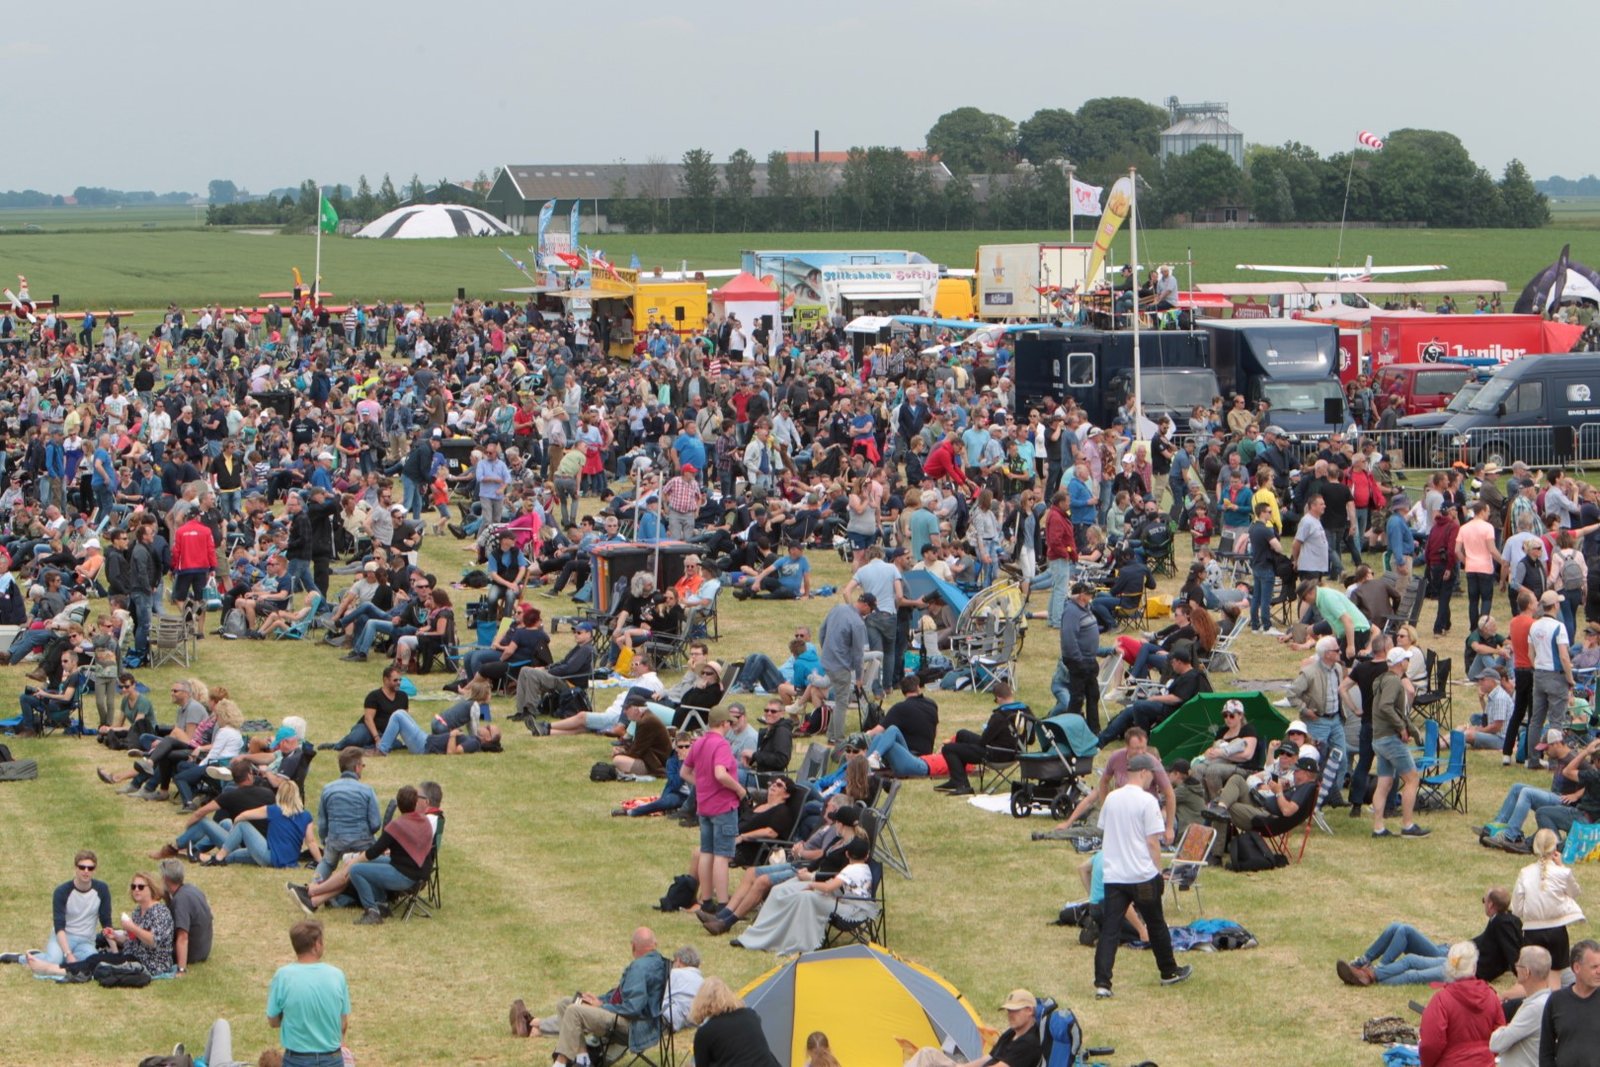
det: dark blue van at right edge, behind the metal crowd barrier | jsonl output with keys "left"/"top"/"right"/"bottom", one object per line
{"left": 1440, "top": 352, "right": 1600, "bottom": 467}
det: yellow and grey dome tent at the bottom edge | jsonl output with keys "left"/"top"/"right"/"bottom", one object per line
{"left": 739, "top": 945, "right": 984, "bottom": 1067}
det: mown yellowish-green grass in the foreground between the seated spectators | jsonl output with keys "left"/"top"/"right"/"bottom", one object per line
{"left": 0, "top": 521, "right": 1561, "bottom": 1067}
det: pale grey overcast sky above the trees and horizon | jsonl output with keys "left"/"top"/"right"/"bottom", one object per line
{"left": 9, "top": 0, "right": 1600, "bottom": 192}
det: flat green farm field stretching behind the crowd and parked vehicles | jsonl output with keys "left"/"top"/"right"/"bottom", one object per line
{"left": 0, "top": 220, "right": 1600, "bottom": 313}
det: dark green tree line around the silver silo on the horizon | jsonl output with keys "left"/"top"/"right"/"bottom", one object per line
{"left": 606, "top": 96, "right": 1550, "bottom": 232}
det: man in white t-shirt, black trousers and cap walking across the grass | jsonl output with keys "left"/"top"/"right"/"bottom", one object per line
{"left": 1094, "top": 752, "right": 1194, "bottom": 1000}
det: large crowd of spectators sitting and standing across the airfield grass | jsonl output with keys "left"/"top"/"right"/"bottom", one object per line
{"left": 9, "top": 286, "right": 1600, "bottom": 1067}
